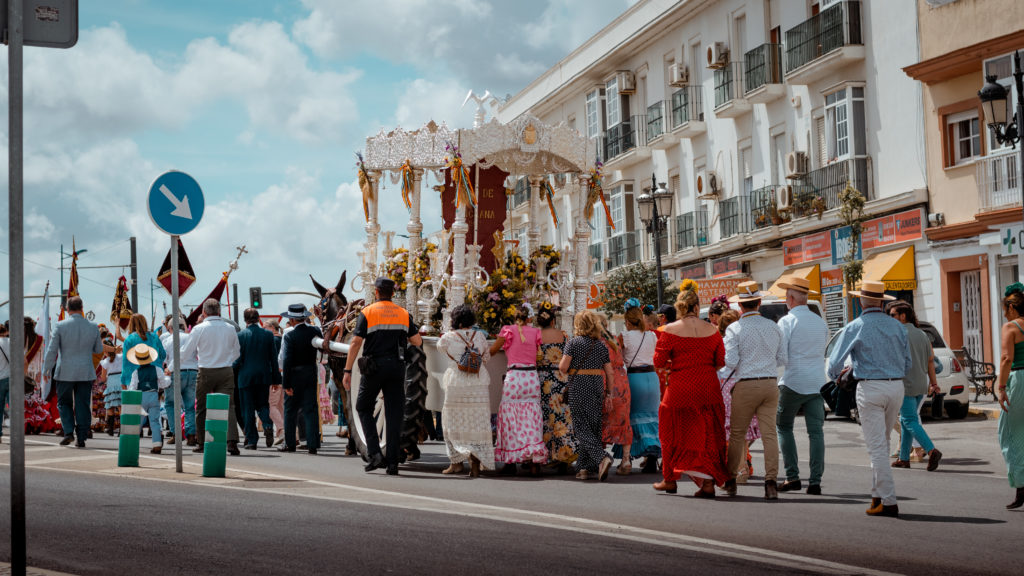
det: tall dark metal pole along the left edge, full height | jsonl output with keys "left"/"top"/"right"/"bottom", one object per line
{"left": 7, "top": 0, "right": 27, "bottom": 576}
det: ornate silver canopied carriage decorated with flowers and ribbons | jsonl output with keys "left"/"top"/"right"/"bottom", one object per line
{"left": 316, "top": 108, "right": 606, "bottom": 458}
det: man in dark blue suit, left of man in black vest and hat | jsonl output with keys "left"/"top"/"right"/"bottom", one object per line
{"left": 234, "top": 308, "right": 281, "bottom": 450}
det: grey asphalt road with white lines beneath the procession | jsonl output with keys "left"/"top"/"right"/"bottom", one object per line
{"left": 0, "top": 412, "right": 1024, "bottom": 574}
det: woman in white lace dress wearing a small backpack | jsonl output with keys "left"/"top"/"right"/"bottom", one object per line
{"left": 437, "top": 304, "right": 495, "bottom": 478}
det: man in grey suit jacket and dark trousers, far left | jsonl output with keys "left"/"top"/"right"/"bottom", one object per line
{"left": 43, "top": 296, "right": 103, "bottom": 448}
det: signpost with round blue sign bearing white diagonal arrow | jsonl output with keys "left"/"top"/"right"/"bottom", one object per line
{"left": 147, "top": 170, "right": 206, "bottom": 472}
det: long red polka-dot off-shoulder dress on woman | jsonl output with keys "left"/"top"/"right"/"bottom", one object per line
{"left": 654, "top": 332, "right": 729, "bottom": 486}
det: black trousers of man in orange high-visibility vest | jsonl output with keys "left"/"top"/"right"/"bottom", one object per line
{"left": 355, "top": 358, "right": 406, "bottom": 464}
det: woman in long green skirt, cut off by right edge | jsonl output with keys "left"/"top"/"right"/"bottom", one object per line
{"left": 995, "top": 282, "right": 1024, "bottom": 509}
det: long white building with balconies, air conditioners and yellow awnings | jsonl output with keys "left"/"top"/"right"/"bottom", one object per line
{"left": 499, "top": 0, "right": 935, "bottom": 326}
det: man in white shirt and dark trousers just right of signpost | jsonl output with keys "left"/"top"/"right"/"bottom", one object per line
{"left": 181, "top": 298, "right": 242, "bottom": 456}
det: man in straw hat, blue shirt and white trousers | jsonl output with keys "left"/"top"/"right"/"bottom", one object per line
{"left": 828, "top": 280, "right": 912, "bottom": 518}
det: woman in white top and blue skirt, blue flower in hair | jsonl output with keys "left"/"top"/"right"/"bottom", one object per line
{"left": 618, "top": 298, "right": 662, "bottom": 472}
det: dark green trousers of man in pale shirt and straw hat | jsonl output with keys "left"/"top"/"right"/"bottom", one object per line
{"left": 775, "top": 386, "right": 825, "bottom": 485}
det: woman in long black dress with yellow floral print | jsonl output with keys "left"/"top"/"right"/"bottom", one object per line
{"left": 537, "top": 301, "right": 577, "bottom": 472}
